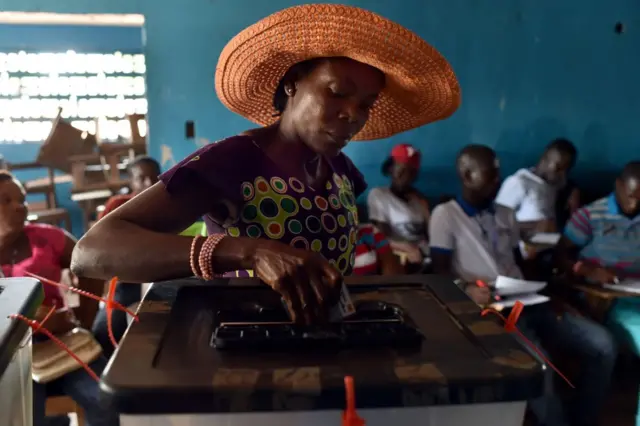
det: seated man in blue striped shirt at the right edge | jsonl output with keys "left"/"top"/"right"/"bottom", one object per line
{"left": 558, "top": 161, "right": 640, "bottom": 355}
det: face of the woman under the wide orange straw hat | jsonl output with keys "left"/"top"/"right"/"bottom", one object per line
{"left": 282, "top": 58, "right": 385, "bottom": 156}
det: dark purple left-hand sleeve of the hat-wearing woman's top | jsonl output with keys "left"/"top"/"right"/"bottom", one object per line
{"left": 160, "top": 136, "right": 256, "bottom": 203}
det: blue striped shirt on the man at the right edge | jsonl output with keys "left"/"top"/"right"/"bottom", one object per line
{"left": 564, "top": 194, "right": 640, "bottom": 277}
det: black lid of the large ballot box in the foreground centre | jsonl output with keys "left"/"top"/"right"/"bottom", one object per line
{"left": 100, "top": 275, "right": 544, "bottom": 414}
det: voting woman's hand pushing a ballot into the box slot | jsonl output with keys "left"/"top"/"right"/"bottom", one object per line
{"left": 253, "top": 241, "right": 342, "bottom": 324}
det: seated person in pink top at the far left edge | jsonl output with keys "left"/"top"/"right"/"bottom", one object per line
{"left": 0, "top": 172, "right": 119, "bottom": 426}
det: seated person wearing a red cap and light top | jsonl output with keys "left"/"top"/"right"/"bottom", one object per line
{"left": 367, "top": 144, "right": 430, "bottom": 269}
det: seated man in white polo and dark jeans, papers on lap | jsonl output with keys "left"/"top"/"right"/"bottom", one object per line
{"left": 429, "top": 145, "right": 616, "bottom": 425}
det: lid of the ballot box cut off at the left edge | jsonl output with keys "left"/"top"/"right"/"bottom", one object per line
{"left": 0, "top": 278, "right": 44, "bottom": 377}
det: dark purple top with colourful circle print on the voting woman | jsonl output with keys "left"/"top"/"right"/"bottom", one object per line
{"left": 161, "top": 136, "right": 366, "bottom": 276}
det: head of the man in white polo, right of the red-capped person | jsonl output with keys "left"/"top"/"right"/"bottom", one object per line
{"left": 456, "top": 145, "right": 500, "bottom": 204}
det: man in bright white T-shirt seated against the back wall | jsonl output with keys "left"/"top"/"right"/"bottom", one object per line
{"left": 496, "top": 139, "right": 578, "bottom": 232}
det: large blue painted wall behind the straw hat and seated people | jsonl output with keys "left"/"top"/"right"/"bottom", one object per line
{"left": 0, "top": 0, "right": 640, "bottom": 221}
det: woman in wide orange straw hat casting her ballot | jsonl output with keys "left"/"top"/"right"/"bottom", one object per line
{"left": 73, "top": 4, "right": 460, "bottom": 321}
